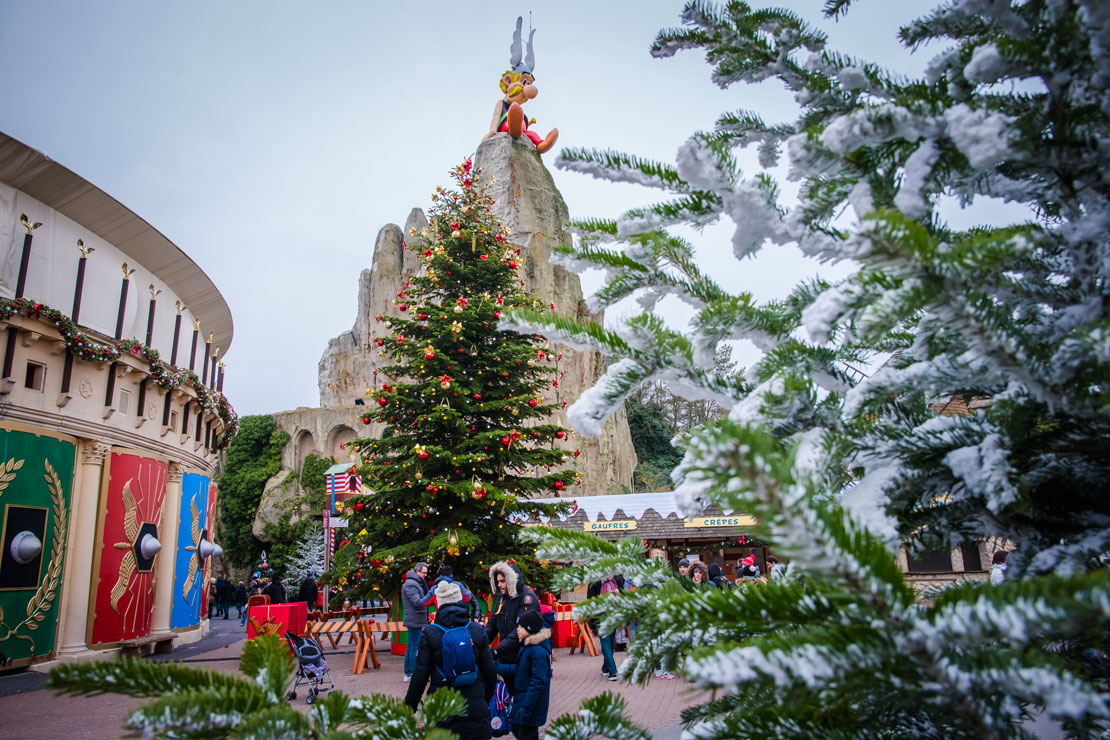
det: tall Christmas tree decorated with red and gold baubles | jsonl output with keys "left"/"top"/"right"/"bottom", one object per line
{"left": 327, "top": 160, "right": 576, "bottom": 599}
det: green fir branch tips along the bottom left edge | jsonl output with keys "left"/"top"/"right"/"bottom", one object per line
{"left": 47, "top": 635, "right": 466, "bottom": 740}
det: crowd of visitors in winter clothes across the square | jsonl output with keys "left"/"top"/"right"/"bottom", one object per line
{"left": 209, "top": 550, "right": 781, "bottom": 740}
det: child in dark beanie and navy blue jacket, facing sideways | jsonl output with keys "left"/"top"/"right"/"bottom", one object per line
{"left": 508, "top": 611, "right": 552, "bottom": 740}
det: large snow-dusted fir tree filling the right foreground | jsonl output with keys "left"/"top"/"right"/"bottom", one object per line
{"left": 513, "top": 0, "right": 1110, "bottom": 740}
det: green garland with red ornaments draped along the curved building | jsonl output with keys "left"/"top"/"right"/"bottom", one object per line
{"left": 0, "top": 298, "right": 239, "bottom": 449}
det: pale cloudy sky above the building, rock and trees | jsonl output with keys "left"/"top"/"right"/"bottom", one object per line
{"left": 0, "top": 0, "right": 935, "bottom": 415}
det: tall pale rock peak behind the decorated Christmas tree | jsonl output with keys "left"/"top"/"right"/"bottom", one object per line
{"left": 319, "top": 134, "right": 636, "bottom": 496}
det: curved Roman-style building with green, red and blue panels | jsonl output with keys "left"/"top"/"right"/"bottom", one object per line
{"left": 0, "top": 133, "right": 238, "bottom": 670}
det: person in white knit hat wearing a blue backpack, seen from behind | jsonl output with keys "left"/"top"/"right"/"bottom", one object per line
{"left": 405, "top": 581, "right": 499, "bottom": 740}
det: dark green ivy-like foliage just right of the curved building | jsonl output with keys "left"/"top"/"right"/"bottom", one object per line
{"left": 218, "top": 416, "right": 289, "bottom": 567}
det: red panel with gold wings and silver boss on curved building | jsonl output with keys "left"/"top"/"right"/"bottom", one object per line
{"left": 90, "top": 452, "right": 166, "bottom": 645}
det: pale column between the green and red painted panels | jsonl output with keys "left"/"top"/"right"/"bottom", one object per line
{"left": 58, "top": 439, "right": 111, "bottom": 660}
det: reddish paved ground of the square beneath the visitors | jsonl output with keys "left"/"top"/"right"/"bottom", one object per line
{"left": 0, "top": 619, "right": 704, "bottom": 740}
